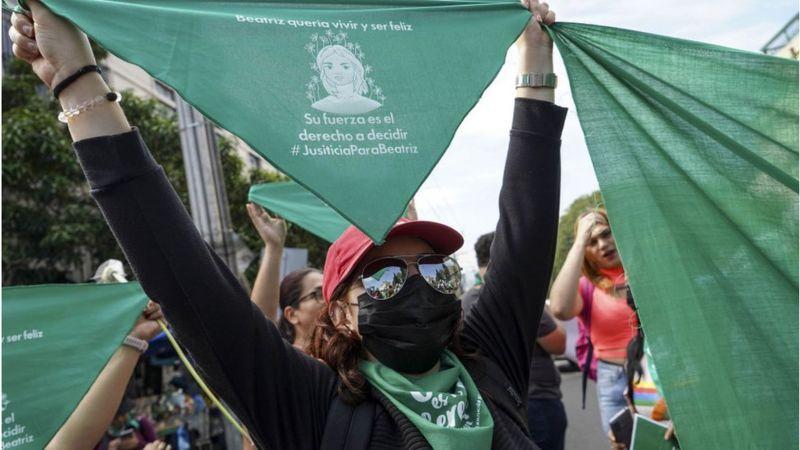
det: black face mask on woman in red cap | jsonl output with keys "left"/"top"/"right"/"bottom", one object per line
{"left": 358, "top": 275, "right": 461, "bottom": 374}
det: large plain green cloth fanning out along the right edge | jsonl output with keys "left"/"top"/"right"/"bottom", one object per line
{"left": 552, "top": 23, "right": 798, "bottom": 450}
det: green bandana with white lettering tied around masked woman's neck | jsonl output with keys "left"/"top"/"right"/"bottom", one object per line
{"left": 360, "top": 350, "right": 494, "bottom": 450}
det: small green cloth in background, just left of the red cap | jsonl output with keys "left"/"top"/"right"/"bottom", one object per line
{"left": 248, "top": 181, "right": 350, "bottom": 242}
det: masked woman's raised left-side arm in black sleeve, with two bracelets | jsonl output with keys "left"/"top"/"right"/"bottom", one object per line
{"left": 12, "top": 1, "right": 336, "bottom": 449}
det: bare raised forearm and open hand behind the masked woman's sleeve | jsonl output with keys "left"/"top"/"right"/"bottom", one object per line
{"left": 247, "top": 203, "right": 286, "bottom": 322}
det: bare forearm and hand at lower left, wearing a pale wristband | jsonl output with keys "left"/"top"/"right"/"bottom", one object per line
{"left": 45, "top": 302, "right": 162, "bottom": 450}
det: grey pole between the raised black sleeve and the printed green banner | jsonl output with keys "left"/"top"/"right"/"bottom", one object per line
{"left": 175, "top": 98, "right": 239, "bottom": 277}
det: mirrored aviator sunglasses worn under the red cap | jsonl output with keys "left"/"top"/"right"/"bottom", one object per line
{"left": 360, "top": 254, "right": 461, "bottom": 300}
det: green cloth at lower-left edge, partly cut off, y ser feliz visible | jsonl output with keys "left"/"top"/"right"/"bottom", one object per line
{"left": 2, "top": 283, "right": 147, "bottom": 449}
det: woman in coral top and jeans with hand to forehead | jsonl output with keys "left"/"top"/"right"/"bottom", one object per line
{"left": 550, "top": 209, "right": 638, "bottom": 440}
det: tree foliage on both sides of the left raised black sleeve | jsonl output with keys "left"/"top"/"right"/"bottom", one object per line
{"left": 2, "top": 60, "right": 326, "bottom": 285}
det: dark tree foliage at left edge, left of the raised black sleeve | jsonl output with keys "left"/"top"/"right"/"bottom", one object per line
{"left": 2, "top": 60, "right": 115, "bottom": 285}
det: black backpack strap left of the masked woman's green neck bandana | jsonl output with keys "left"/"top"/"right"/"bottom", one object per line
{"left": 320, "top": 396, "right": 375, "bottom": 450}
